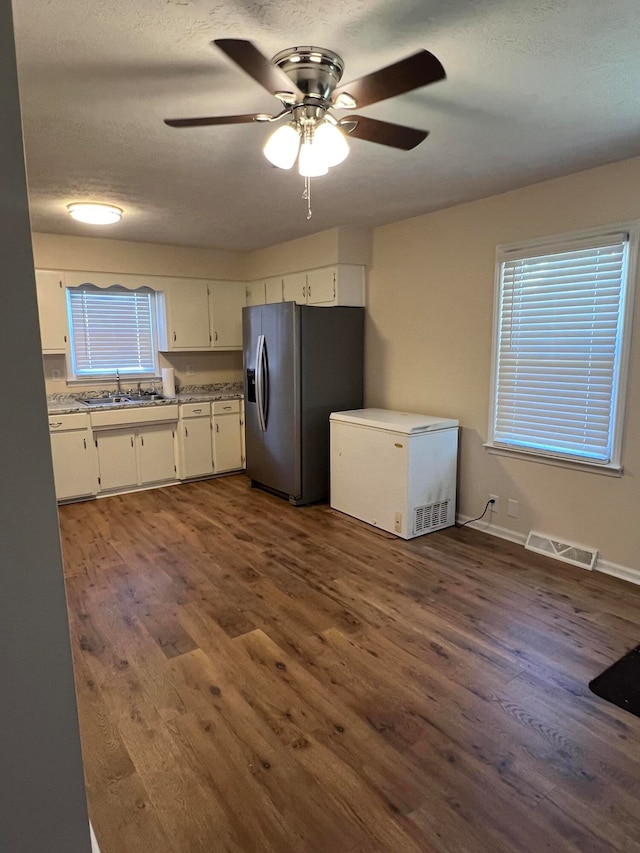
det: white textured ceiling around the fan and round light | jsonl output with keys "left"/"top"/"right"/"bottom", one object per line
{"left": 14, "top": 0, "right": 640, "bottom": 250}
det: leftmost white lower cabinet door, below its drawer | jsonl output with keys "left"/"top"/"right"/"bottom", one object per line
{"left": 51, "top": 430, "right": 98, "bottom": 501}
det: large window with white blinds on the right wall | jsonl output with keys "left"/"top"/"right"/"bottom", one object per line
{"left": 489, "top": 226, "right": 637, "bottom": 469}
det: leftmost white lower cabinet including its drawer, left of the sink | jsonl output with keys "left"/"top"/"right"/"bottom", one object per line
{"left": 49, "top": 413, "right": 98, "bottom": 501}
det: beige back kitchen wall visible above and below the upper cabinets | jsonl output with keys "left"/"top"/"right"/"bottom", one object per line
{"left": 35, "top": 233, "right": 246, "bottom": 394}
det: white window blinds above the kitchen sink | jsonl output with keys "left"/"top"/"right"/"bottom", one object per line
{"left": 67, "top": 287, "right": 156, "bottom": 377}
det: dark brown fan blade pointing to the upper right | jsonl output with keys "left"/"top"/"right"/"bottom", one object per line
{"left": 331, "top": 50, "right": 446, "bottom": 107}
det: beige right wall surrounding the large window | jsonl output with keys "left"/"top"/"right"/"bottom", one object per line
{"left": 366, "top": 159, "right": 640, "bottom": 569}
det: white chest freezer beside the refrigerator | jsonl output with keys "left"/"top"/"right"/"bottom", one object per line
{"left": 329, "top": 409, "right": 458, "bottom": 539}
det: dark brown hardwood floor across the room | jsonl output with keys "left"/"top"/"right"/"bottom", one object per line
{"left": 60, "top": 476, "right": 640, "bottom": 853}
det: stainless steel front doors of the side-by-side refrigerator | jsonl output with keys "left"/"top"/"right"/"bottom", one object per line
{"left": 243, "top": 302, "right": 301, "bottom": 498}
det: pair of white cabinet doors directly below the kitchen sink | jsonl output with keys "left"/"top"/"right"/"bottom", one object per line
{"left": 95, "top": 424, "right": 176, "bottom": 492}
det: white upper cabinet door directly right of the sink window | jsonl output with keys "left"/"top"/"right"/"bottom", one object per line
{"left": 156, "top": 278, "right": 211, "bottom": 352}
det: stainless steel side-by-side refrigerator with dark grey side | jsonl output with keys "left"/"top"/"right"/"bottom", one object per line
{"left": 242, "top": 302, "right": 364, "bottom": 506}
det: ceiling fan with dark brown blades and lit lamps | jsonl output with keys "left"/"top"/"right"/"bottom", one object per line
{"left": 165, "top": 39, "right": 446, "bottom": 218}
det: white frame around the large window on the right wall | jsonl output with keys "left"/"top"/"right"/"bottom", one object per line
{"left": 484, "top": 220, "right": 640, "bottom": 475}
